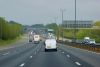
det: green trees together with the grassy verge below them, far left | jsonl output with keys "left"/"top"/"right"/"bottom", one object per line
{"left": 0, "top": 17, "right": 23, "bottom": 46}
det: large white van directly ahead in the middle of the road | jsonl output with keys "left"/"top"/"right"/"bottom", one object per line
{"left": 45, "top": 35, "right": 57, "bottom": 52}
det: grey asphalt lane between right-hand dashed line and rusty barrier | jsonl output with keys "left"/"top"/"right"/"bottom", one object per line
{"left": 59, "top": 44, "right": 100, "bottom": 67}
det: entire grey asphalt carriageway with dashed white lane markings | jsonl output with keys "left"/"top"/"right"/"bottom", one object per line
{"left": 0, "top": 41, "right": 100, "bottom": 67}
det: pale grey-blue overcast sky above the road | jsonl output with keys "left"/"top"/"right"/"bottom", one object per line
{"left": 0, "top": 0, "right": 100, "bottom": 25}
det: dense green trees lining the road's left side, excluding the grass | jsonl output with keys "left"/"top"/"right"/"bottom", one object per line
{"left": 0, "top": 17, "right": 23, "bottom": 40}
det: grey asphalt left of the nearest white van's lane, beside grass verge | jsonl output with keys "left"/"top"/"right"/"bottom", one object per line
{"left": 0, "top": 42, "right": 42, "bottom": 67}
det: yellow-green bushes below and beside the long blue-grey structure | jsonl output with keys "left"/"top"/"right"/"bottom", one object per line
{"left": 64, "top": 21, "right": 100, "bottom": 42}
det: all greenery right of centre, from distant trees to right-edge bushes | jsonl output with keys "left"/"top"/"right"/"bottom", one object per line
{"left": 46, "top": 21, "right": 100, "bottom": 43}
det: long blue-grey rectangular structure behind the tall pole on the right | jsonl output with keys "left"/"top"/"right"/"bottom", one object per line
{"left": 62, "top": 20, "right": 93, "bottom": 28}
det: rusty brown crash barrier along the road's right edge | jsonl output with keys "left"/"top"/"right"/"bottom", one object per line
{"left": 57, "top": 40, "right": 100, "bottom": 52}
